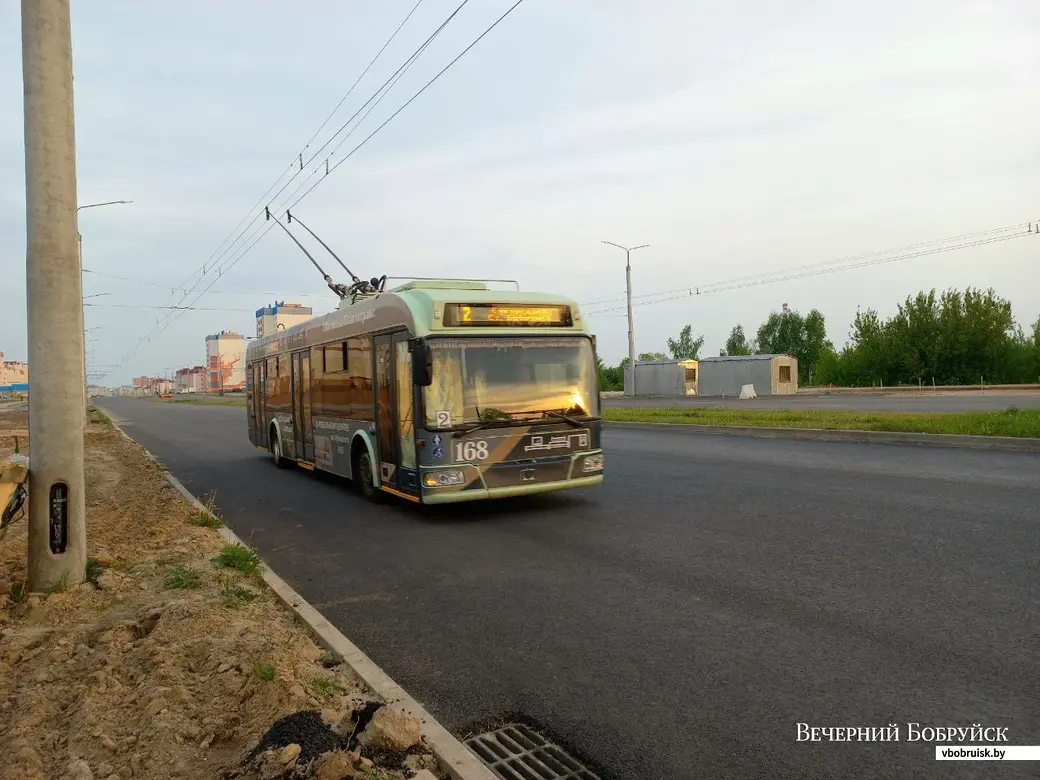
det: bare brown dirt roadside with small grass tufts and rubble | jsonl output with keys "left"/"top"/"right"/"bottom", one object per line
{"left": 0, "top": 411, "right": 439, "bottom": 780}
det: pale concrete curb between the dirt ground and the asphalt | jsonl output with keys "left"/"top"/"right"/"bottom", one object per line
{"left": 108, "top": 415, "right": 497, "bottom": 780}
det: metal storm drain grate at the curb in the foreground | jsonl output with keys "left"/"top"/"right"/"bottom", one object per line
{"left": 466, "top": 724, "right": 599, "bottom": 780}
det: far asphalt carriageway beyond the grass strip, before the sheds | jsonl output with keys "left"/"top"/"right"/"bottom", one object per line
{"left": 603, "top": 390, "right": 1040, "bottom": 412}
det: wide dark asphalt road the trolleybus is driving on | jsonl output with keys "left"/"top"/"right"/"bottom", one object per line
{"left": 103, "top": 398, "right": 1040, "bottom": 780}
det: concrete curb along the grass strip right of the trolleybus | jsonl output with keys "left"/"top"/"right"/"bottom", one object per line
{"left": 604, "top": 420, "right": 1040, "bottom": 452}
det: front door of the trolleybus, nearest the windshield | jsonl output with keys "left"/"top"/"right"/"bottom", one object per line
{"left": 374, "top": 331, "right": 419, "bottom": 496}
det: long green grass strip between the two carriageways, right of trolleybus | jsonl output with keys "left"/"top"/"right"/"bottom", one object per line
{"left": 603, "top": 407, "right": 1040, "bottom": 438}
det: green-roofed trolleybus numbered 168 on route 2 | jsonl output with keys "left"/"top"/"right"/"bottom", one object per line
{"left": 245, "top": 278, "right": 603, "bottom": 503}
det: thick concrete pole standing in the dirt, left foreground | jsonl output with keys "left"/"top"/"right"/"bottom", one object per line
{"left": 22, "top": 0, "right": 86, "bottom": 592}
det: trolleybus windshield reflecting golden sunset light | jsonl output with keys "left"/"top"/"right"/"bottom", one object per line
{"left": 423, "top": 337, "right": 599, "bottom": 428}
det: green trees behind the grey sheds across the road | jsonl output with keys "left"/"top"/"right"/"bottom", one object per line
{"left": 599, "top": 287, "right": 1040, "bottom": 391}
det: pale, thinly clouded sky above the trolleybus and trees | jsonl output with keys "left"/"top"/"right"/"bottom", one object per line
{"left": 0, "top": 0, "right": 1040, "bottom": 385}
